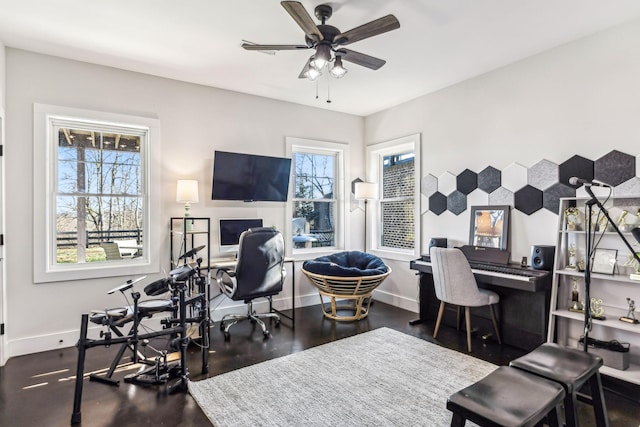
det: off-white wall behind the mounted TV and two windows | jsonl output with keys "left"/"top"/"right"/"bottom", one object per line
{"left": 5, "top": 48, "right": 364, "bottom": 357}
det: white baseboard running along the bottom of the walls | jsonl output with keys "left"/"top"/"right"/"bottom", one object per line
{"left": 5, "top": 290, "right": 418, "bottom": 360}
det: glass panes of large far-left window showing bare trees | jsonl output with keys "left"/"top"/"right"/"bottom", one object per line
{"left": 54, "top": 123, "right": 144, "bottom": 264}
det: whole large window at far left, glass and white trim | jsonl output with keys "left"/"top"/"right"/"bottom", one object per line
{"left": 34, "top": 104, "right": 159, "bottom": 282}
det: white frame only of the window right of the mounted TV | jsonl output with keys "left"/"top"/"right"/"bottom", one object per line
{"left": 285, "top": 137, "right": 349, "bottom": 259}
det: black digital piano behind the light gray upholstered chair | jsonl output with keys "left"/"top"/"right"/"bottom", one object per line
{"left": 410, "top": 260, "right": 551, "bottom": 351}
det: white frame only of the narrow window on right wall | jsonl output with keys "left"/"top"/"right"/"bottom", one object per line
{"left": 365, "top": 133, "right": 422, "bottom": 261}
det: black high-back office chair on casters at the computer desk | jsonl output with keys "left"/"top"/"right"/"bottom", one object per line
{"left": 216, "top": 227, "right": 286, "bottom": 341}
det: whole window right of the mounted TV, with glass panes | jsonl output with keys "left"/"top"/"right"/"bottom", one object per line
{"left": 287, "top": 138, "right": 346, "bottom": 253}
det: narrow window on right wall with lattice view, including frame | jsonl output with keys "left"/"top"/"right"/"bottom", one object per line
{"left": 367, "top": 135, "right": 420, "bottom": 259}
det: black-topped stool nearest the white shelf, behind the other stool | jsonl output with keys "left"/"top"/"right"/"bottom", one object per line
{"left": 509, "top": 343, "right": 609, "bottom": 427}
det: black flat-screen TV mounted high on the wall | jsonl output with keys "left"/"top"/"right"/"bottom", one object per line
{"left": 211, "top": 151, "right": 291, "bottom": 202}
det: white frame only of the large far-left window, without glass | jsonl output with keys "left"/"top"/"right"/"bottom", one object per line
{"left": 33, "top": 104, "right": 162, "bottom": 283}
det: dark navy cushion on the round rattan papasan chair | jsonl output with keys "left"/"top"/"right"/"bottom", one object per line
{"left": 302, "top": 251, "right": 388, "bottom": 277}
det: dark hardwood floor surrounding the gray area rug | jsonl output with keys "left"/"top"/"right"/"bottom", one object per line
{"left": 0, "top": 302, "right": 640, "bottom": 427}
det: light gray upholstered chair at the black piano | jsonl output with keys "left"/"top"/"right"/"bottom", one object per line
{"left": 431, "top": 247, "right": 502, "bottom": 352}
